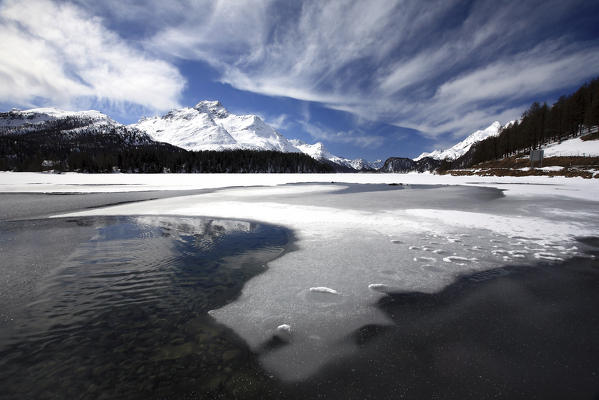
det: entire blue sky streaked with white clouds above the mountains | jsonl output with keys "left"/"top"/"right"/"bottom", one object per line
{"left": 0, "top": 0, "right": 599, "bottom": 160}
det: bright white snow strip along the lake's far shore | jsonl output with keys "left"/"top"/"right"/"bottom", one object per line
{"left": 0, "top": 171, "right": 599, "bottom": 203}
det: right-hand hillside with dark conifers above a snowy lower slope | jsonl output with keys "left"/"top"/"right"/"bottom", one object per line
{"left": 440, "top": 78, "right": 599, "bottom": 178}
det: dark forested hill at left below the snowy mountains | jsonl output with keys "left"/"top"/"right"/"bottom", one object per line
{"left": 0, "top": 113, "right": 333, "bottom": 173}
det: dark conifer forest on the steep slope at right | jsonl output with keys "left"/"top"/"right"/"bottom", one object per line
{"left": 448, "top": 78, "right": 599, "bottom": 169}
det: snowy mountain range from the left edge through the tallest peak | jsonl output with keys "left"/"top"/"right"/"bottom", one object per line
{"left": 0, "top": 101, "right": 382, "bottom": 171}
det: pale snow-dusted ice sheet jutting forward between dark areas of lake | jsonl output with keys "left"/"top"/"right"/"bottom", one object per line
{"left": 38, "top": 178, "right": 599, "bottom": 380}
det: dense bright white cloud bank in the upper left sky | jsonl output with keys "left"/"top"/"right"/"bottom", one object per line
{"left": 0, "top": 0, "right": 185, "bottom": 110}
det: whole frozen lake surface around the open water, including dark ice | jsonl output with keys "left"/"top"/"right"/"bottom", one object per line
{"left": 0, "top": 173, "right": 599, "bottom": 398}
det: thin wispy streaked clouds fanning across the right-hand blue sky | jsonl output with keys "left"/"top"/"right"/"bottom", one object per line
{"left": 132, "top": 0, "right": 599, "bottom": 136}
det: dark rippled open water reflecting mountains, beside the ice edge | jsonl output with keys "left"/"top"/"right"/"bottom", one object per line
{"left": 0, "top": 217, "right": 288, "bottom": 398}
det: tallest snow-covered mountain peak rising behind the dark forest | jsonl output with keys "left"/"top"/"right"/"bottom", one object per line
{"left": 130, "top": 101, "right": 380, "bottom": 170}
